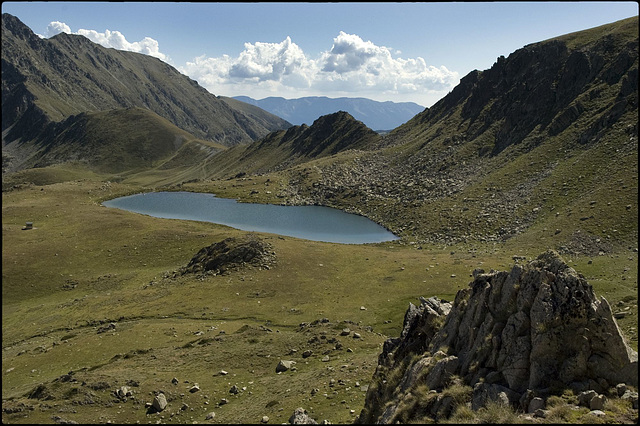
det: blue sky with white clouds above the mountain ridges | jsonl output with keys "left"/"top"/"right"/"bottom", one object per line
{"left": 2, "top": 1, "right": 638, "bottom": 107}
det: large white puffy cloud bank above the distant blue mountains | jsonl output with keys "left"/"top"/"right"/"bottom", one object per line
{"left": 180, "top": 31, "right": 459, "bottom": 105}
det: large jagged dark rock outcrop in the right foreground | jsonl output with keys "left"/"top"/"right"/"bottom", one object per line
{"left": 359, "top": 251, "right": 638, "bottom": 423}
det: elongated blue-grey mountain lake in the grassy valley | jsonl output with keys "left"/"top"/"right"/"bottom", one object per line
{"left": 102, "top": 192, "right": 398, "bottom": 244}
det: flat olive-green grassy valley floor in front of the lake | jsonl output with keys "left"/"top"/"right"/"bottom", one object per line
{"left": 2, "top": 178, "right": 638, "bottom": 423}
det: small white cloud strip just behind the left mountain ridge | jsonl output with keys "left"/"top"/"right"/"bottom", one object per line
{"left": 46, "top": 21, "right": 170, "bottom": 62}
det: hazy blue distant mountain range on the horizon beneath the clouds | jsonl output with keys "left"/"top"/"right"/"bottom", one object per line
{"left": 234, "top": 96, "right": 425, "bottom": 131}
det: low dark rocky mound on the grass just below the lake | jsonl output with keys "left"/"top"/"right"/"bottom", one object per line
{"left": 181, "top": 236, "right": 275, "bottom": 274}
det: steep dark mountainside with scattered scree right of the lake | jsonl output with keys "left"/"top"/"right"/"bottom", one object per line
{"left": 220, "top": 18, "right": 638, "bottom": 253}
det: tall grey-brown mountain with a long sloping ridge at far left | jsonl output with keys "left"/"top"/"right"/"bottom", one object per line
{"left": 2, "top": 14, "right": 290, "bottom": 154}
